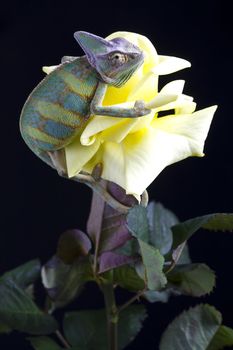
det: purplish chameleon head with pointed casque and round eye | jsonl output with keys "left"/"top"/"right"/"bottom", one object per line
{"left": 74, "top": 31, "right": 144, "bottom": 87}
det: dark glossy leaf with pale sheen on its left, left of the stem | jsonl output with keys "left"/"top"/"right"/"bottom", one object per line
{"left": 41, "top": 256, "right": 93, "bottom": 309}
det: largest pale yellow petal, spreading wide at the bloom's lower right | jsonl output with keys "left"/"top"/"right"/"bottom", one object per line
{"left": 123, "top": 106, "right": 216, "bottom": 195}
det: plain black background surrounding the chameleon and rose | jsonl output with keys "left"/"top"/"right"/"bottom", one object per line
{"left": 0, "top": 0, "right": 233, "bottom": 350}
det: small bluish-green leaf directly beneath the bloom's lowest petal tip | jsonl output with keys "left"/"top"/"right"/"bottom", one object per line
{"left": 126, "top": 205, "right": 149, "bottom": 242}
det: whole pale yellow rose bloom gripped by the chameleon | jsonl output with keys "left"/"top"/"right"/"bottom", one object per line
{"left": 44, "top": 32, "right": 217, "bottom": 199}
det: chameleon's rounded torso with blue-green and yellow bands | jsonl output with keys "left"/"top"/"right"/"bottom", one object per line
{"left": 20, "top": 56, "right": 99, "bottom": 166}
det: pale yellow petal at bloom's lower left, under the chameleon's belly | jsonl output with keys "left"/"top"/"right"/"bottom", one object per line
{"left": 65, "top": 137, "right": 100, "bottom": 177}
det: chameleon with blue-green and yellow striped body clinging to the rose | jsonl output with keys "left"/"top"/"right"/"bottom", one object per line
{"left": 20, "top": 31, "right": 150, "bottom": 180}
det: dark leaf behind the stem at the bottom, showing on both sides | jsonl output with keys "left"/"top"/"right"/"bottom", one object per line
{"left": 64, "top": 305, "right": 147, "bottom": 350}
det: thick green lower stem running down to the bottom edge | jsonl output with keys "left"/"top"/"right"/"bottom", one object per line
{"left": 101, "top": 281, "right": 118, "bottom": 350}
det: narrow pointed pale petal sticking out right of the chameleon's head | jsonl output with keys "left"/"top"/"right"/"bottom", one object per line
{"left": 153, "top": 55, "right": 191, "bottom": 75}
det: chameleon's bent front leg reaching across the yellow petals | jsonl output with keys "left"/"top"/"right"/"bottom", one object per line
{"left": 90, "top": 82, "right": 151, "bottom": 118}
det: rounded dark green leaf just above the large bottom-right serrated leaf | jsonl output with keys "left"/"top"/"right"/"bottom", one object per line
{"left": 167, "top": 264, "right": 215, "bottom": 297}
